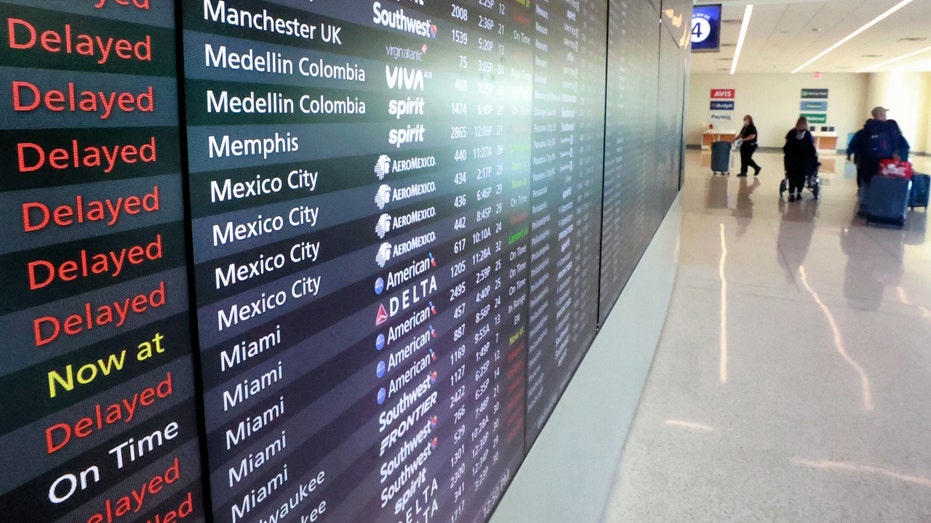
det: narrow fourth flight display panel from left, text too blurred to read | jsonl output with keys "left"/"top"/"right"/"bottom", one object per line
{"left": 599, "top": 0, "right": 665, "bottom": 322}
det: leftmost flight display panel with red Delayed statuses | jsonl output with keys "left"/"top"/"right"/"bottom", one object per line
{"left": 0, "top": 1, "right": 205, "bottom": 522}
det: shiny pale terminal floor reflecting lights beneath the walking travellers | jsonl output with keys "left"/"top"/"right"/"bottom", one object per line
{"left": 605, "top": 150, "right": 931, "bottom": 522}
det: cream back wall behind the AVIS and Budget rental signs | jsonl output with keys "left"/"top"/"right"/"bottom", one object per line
{"left": 685, "top": 73, "right": 872, "bottom": 148}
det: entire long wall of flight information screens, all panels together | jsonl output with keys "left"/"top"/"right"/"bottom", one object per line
{"left": 0, "top": 0, "right": 685, "bottom": 523}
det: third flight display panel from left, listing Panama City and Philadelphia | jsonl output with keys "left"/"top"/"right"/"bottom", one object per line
{"left": 527, "top": 0, "right": 607, "bottom": 445}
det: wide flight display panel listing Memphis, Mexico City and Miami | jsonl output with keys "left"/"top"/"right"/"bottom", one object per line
{"left": 183, "top": 0, "right": 532, "bottom": 522}
